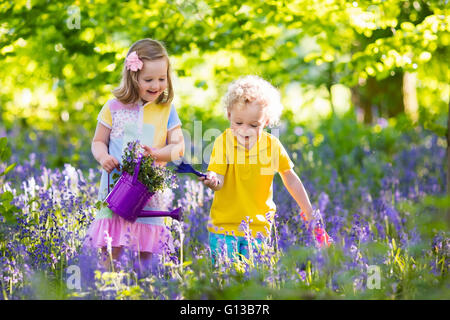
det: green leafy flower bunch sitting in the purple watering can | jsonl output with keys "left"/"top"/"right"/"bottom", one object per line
{"left": 122, "top": 140, "right": 178, "bottom": 193}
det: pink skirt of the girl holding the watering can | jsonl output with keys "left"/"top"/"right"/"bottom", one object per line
{"left": 84, "top": 209, "right": 174, "bottom": 254}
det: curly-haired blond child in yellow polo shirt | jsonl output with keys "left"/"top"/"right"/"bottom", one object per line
{"left": 199, "top": 76, "right": 331, "bottom": 261}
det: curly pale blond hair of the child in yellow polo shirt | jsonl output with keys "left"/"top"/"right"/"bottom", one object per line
{"left": 223, "top": 75, "right": 283, "bottom": 127}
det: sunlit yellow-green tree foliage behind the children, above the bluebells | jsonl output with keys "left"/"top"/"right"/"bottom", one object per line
{"left": 0, "top": 0, "right": 450, "bottom": 168}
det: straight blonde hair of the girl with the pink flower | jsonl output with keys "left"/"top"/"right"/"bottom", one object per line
{"left": 113, "top": 39, "right": 174, "bottom": 104}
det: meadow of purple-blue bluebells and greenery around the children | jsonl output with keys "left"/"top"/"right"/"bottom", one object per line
{"left": 0, "top": 115, "right": 450, "bottom": 299}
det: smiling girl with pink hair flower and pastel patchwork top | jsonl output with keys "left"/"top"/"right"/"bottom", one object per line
{"left": 87, "top": 39, "right": 184, "bottom": 272}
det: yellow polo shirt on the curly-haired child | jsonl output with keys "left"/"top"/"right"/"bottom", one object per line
{"left": 208, "top": 129, "right": 294, "bottom": 237}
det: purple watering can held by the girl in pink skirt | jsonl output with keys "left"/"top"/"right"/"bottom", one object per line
{"left": 106, "top": 156, "right": 182, "bottom": 222}
